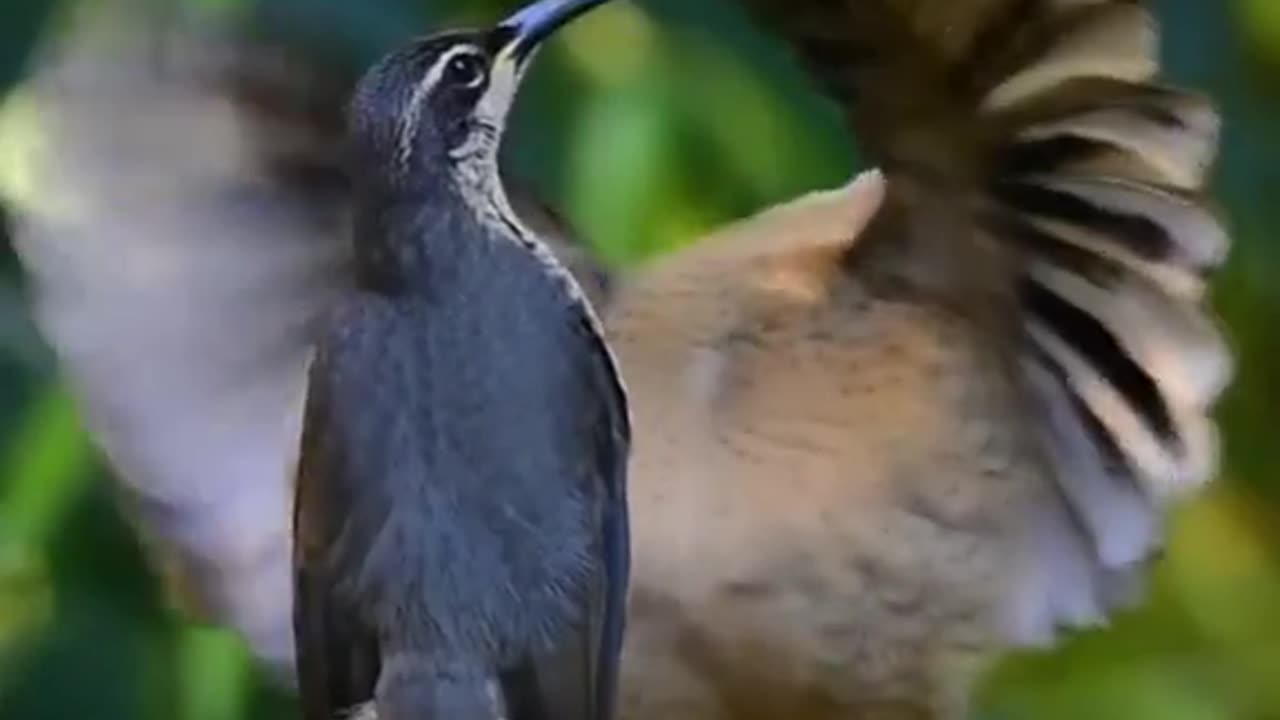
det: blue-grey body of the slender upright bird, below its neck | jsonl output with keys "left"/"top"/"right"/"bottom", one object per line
{"left": 296, "top": 228, "right": 625, "bottom": 717}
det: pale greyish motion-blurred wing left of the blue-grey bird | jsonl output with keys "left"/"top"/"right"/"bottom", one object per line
{"left": 17, "top": 4, "right": 347, "bottom": 666}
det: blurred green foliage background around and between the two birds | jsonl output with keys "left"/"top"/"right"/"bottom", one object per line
{"left": 0, "top": 0, "right": 1280, "bottom": 720}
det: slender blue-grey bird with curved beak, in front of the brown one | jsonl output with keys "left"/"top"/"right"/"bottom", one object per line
{"left": 293, "top": 0, "right": 630, "bottom": 720}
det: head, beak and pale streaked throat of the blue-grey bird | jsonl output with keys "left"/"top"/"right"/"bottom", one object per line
{"left": 349, "top": 0, "right": 614, "bottom": 333}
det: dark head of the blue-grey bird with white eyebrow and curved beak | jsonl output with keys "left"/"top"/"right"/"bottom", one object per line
{"left": 349, "top": 0, "right": 607, "bottom": 193}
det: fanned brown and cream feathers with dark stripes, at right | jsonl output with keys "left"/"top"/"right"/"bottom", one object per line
{"left": 744, "top": 0, "right": 1231, "bottom": 639}
